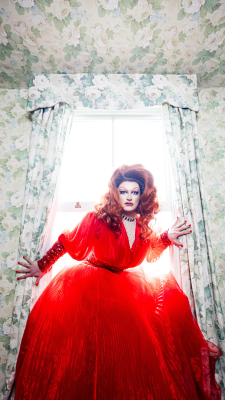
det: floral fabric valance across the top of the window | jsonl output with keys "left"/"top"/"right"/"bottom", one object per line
{"left": 27, "top": 73, "right": 199, "bottom": 111}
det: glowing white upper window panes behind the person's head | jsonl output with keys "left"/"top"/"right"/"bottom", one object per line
{"left": 60, "top": 117, "right": 166, "bottom": 202}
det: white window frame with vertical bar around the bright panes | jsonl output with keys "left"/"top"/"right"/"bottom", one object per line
{"left": 57, "top": 106, "right": 172, "bottom": 212}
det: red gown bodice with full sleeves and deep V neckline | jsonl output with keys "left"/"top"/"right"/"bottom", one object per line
{"left": 39, "top": 212, "right": 170, "bottom": 271}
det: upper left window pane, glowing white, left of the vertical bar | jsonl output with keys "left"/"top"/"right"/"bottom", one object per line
{"left": 60, "top": 120, "right": 112, "bottom": 202}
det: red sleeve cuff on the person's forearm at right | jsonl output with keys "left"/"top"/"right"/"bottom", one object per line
{"left": 146, "top": 229, "right": 171, "bottom": 262}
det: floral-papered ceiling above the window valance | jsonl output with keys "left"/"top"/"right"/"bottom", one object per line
{"left": 0, "top": 0, "right": 225, "bottom": 88}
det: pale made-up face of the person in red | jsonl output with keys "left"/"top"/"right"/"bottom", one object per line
{"left": 118, "top": 181, "right": 141, "bottom": 217}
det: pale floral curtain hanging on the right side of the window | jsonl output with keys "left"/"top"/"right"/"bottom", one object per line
{"left": 163, "top": 104, "right": 225, "bottom": 394}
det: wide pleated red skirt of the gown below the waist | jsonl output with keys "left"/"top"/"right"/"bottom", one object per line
{"left": 15, "top": 261, "right": 222, "bottom": 400}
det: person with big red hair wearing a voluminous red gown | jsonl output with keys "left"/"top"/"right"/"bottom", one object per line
{"left": 15, "top": 164, "right": 222, "bottom": 400}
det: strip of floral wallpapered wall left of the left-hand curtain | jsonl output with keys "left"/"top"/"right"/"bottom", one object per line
{"left": 0, "top": 89, "right": 31, "bottom": 398}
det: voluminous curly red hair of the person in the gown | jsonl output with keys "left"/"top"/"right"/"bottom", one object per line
{"left": 95, "top": 164, "right": 161, "bottom": 240}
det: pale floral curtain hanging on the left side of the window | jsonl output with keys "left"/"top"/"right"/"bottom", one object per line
{"left": 6, "top": 103, "right": 73, "bottom": 395}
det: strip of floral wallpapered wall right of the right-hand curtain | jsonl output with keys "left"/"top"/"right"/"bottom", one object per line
{"left": 196, "top": 87, "right": 225, "bottom": 390}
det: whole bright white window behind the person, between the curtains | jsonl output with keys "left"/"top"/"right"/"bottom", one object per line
{"left": 48, "top": 106, "right": 172, "bottom": 275}
